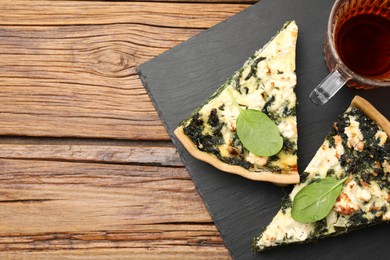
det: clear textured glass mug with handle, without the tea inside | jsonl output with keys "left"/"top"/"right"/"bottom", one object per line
{"left": 309, "top": 0, "right": 390, "bottom": 105}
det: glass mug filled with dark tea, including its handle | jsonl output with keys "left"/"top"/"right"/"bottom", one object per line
{"left": 310, "top": 0, "right": 390, "bottom": 105}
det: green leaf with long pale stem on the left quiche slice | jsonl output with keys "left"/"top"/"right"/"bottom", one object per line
{"left": 228, "top": 90, "right": 283, "bottom": 156}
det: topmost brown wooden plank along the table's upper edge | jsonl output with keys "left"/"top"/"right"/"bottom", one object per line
{"left": 0, "top": 0, "right": 250, "bottom": 28}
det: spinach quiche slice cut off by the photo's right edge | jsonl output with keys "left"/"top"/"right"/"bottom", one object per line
{"left": 254, "top": 96, "right": 390, "bottom": 251}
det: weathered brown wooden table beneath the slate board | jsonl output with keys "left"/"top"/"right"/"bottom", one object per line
{"left": 0, "top": 0, "right": 253, "bottom": 259}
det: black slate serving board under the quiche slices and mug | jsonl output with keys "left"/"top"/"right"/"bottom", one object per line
{"left": 137, "top": 0, "right": 390, "bottom": 259}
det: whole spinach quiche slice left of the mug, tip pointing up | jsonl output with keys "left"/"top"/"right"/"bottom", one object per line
{"left": 175, "top": 21, "right": 299, "bottom": 184}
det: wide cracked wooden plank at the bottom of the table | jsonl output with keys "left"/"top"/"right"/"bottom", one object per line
{"left": 0, "top": 159, "right": 227, "bottom": 259}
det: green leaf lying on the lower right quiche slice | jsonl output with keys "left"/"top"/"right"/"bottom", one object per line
{"left": 291, "top": 177, "right": 347, "bottom": 223}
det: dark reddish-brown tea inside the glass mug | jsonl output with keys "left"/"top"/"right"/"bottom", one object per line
{"left": 335, "top": 14, "right": 390, "bottom": 78}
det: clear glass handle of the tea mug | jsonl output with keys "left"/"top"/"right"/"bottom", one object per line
{"left": 309, "top": 68, "right": 348, "bottom": 106}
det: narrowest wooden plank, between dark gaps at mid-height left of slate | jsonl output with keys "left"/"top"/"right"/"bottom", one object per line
{"left": 0, "top": 144, "right": 183, "bottom": 166}
